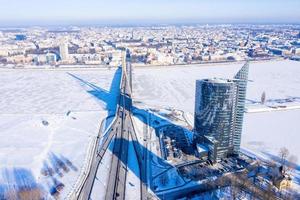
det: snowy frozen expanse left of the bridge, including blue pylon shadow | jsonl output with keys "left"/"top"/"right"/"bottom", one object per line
{"left": 0, "top": 69, "right": 119, "bottom": 199}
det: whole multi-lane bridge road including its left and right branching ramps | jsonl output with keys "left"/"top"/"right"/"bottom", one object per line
{"left": 76, "top": 54, "right": 148, "bottom": 200}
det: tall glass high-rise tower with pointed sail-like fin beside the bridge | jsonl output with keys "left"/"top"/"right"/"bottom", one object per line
{"left": 194, "top": 63, "right": 249, "bottom": 162}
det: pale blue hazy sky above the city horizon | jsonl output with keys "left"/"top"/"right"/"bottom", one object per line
{"left": 0, "top": 0, "right": 300, "bottom": 24}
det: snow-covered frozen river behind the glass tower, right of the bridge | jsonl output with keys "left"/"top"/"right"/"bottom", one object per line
{"left": 133, "top": 60, "right": 300, "bottom": 113}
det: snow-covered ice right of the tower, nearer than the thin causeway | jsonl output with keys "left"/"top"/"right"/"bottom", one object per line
{"left": 242, "top": 110, "right": 300, "bottom": 160}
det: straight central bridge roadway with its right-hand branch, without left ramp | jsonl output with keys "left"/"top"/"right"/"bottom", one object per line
{"left": 106, "top": 54, "right": 147, "bottom": 200}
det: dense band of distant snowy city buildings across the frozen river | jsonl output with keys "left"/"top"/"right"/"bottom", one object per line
{"left": 0, "top": 25, "right": 300, "bottom": 66}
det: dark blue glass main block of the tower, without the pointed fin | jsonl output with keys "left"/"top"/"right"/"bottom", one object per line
{"left": 195, "top": 79, "right": 237, "bottom": 160}
